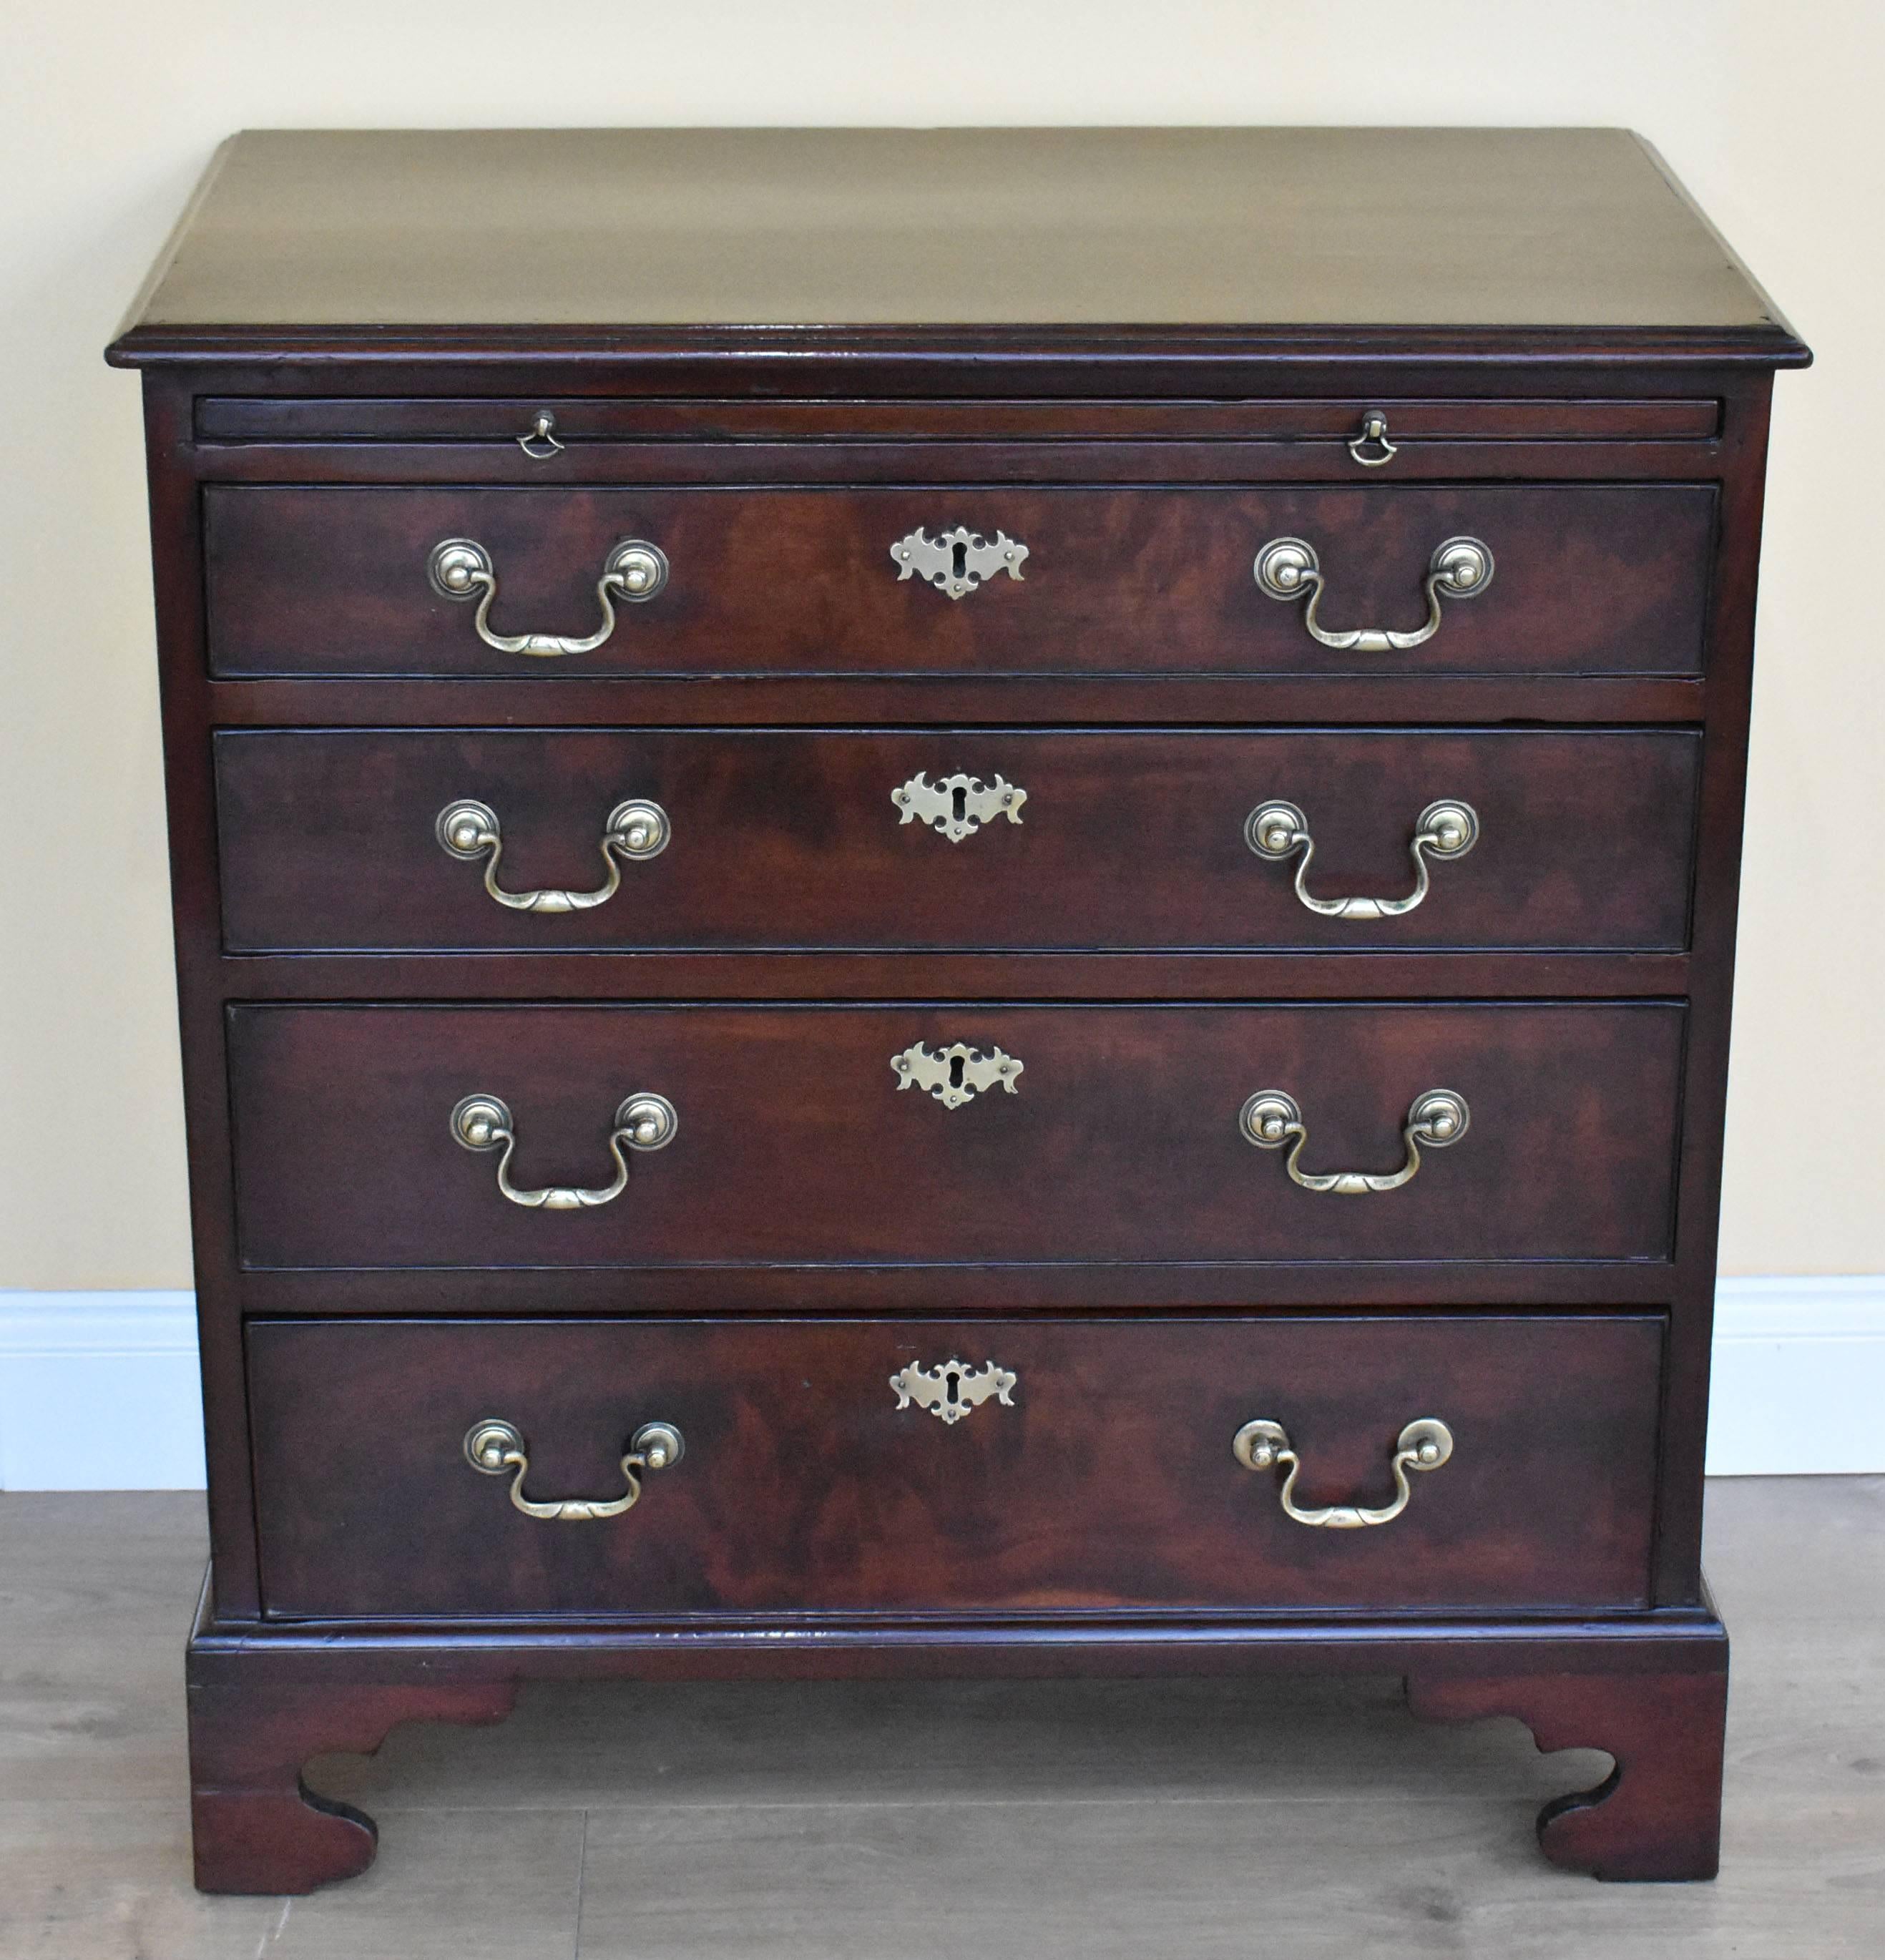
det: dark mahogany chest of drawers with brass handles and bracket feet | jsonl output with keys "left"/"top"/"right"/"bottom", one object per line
{"left": 112, "top": 118, "right": 1806, "bottom": 1891}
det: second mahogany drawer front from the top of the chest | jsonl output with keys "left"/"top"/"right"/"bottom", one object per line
{"left": 215, "top": 729, "right": 1701, "bottom": 951}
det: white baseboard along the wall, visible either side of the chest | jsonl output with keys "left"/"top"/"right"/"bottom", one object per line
{"left": 0, "top": 1274, "right": 1885, "bottom": 1489}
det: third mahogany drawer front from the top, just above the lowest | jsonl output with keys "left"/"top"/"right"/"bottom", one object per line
{"left": 229, "top": 1001, "right": 1683, "bottom": 1268}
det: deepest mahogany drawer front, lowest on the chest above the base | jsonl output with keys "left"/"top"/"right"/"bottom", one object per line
{"left": 249, "top": 1315, "right": 1662, "bottom": 1617}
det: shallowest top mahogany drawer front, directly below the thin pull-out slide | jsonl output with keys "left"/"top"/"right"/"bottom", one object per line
{"left": 204, "top": 484, "right": 1715, "bottom": 676}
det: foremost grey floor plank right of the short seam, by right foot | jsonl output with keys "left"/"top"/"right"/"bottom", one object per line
{"left": 578, "top": 1795, "right": 1885, "bottom": 1960}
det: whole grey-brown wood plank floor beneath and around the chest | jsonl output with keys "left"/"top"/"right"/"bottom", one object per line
{"left": 0, "top": 1478, "right": 1885, "bottom": 1960}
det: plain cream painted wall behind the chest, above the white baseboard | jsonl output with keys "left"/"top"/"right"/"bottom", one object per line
{"left": 0, "top": 0, "right": 1885, "bottom": 1288}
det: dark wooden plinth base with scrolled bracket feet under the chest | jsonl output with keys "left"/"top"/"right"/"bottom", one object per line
{"left": 186, "top": 1587, "right": 1728, "bottom": 1893}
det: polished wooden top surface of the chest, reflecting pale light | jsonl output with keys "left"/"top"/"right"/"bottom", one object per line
{"left": 114, "top": 129, "right": 1797, "bottom": 361}
